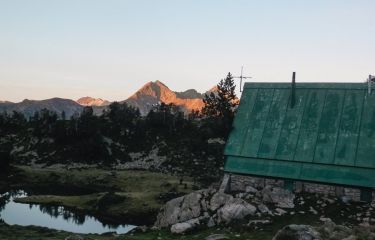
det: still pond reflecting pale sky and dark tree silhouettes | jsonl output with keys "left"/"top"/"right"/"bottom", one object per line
{"left": 0, "top": 191, "right": 135, "bottom": 234}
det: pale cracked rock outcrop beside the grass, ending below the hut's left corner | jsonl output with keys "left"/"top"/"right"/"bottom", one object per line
{"left": 155, "top": 189, "right": 257, "bottom": 233}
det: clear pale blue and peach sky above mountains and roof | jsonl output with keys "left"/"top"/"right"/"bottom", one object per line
{"left": 0, "top": 0, "right": 375, "bottom": 101}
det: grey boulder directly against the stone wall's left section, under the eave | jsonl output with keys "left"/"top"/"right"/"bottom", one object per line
{"left": 259, "top": 187, "right": 295, "bottom": 208}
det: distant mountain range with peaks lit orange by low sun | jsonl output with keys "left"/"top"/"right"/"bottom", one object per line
{"left": 0, "top": 81, "right": 216, "bottom": 118}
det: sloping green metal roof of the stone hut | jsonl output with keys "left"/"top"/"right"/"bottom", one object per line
{"left": 225, "top": 83, "right": 375, "bottom": 188}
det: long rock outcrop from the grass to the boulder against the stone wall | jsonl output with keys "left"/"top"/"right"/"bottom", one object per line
{"left": 155, "top": 187, "right": 302, "bottom": 233}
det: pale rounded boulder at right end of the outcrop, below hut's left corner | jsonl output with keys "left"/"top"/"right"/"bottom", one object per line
{"left": 217, "top": 198, "right": 257, "bottom": 223}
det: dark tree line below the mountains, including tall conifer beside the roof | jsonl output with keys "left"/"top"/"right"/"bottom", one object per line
{"left": 0, "top": 73, "right": 238, "bottom": 182}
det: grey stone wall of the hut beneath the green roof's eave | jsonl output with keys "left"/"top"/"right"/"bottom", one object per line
{"left": 227, "top": 174, "right": 375, "bottom": 201}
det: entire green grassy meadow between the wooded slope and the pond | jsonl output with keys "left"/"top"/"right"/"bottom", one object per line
{"left": 11, "top": 166, "right": 193, "bottom": 224}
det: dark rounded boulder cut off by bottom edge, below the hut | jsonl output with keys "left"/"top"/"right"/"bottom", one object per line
{"left": 272, "top": 224, "right": 322, "bottom": 240}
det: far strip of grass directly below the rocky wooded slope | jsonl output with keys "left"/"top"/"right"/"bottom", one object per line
{"left": 12, "top": 166, "right": 192, "bottom": 192}
